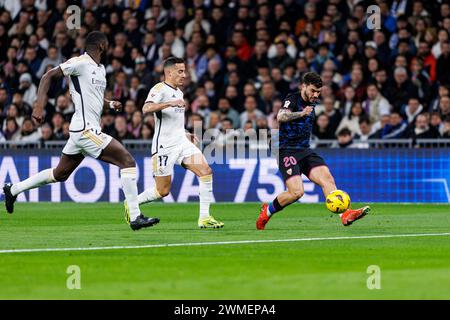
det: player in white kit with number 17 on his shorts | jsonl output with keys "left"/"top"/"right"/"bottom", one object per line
{"left": 134, "top": 57, "right": 224, "bottom": 228}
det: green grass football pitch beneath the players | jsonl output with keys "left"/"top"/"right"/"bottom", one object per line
{"left": 0, "top": 203, "right": 450, "bottom": 300}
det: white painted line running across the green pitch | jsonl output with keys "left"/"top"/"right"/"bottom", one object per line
{"left": 0, "top": 232, "right": 450, "bottom": 254}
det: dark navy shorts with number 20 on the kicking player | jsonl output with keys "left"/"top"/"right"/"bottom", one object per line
{"left": 278, "top": 149, "right": 326, "bottom": 181}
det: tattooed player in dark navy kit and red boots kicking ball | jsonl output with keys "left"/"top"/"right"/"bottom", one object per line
{"left": 256, "top": 72, "right": 370, "bottom": 230}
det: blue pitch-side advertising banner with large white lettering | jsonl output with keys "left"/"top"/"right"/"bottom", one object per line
{"left": 0, "top": 149, "right": 450, "bottom": 203}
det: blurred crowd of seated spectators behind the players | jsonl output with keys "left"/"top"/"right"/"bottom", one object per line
{"left": 0, "top": 0, "right": 450, "bottom": 147}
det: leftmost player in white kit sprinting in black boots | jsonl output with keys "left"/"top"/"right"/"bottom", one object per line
{"left": 3, "top": 31, "right": 159, "bottom": 230}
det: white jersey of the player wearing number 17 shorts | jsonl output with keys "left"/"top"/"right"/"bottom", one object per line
{"left": 146, "top": 82, "right": 187, "bottom": 154}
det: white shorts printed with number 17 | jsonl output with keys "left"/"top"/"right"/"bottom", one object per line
{"left": 152, "top": 139, "right": 202, "bottom": 177}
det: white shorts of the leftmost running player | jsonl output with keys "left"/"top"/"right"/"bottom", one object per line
{"left": 63, "top": 128, "right": 112, "bottom": 158}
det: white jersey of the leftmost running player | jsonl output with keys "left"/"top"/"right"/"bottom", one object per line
{"left": 59, "top": 53, "right": 106, "bottom": 132}
